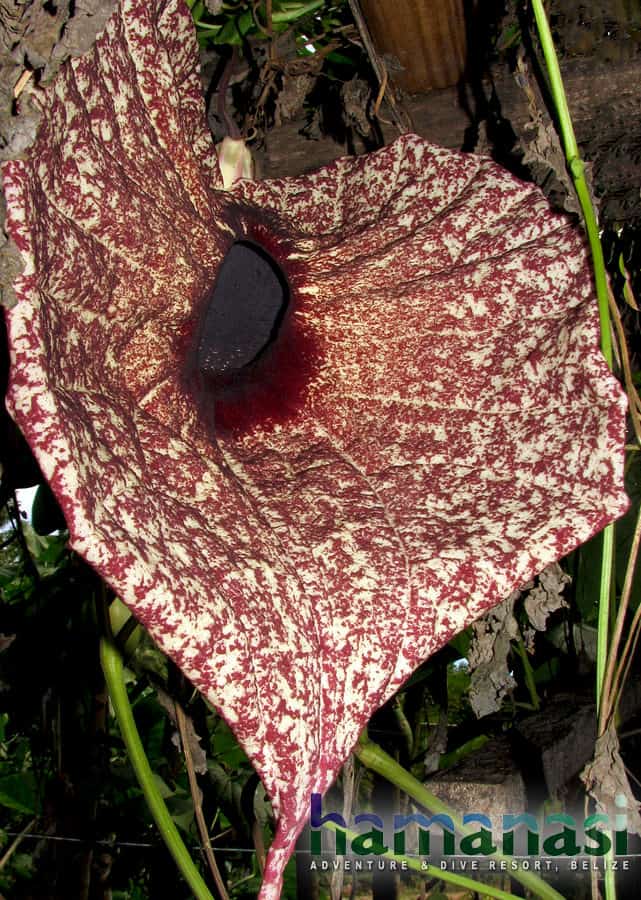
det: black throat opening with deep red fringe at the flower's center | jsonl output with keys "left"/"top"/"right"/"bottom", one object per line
{"left": 185, "top": 236, "right": 316, "bottom": 436}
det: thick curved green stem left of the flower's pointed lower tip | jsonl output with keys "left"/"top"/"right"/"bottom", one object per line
{"left": 100, "top": 637, "right": 213, "bottom": 900}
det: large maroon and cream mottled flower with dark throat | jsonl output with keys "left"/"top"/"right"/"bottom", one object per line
{"left": 4, "top": 0, "right": 626, "bottom": 900}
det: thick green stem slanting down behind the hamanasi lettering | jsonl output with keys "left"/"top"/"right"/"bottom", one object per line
{"left": 354, "top": 735, "right": 563, "bottom": 900}
